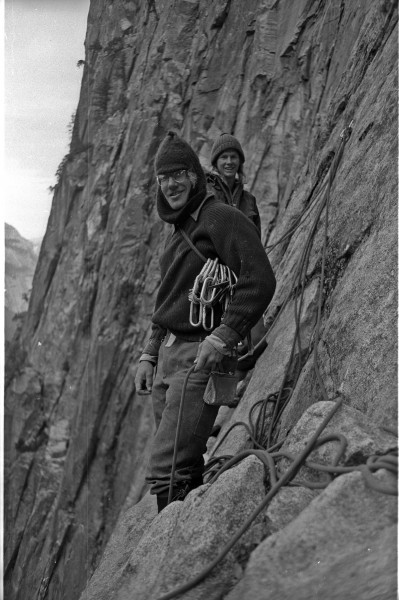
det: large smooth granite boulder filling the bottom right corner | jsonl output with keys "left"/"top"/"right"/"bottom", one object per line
{"left": 226, "top": 472, "right": 397, "bottom": 600}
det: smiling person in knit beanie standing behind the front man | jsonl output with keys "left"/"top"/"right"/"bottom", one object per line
{"left": 207, "top": 133, "right": 261, "bottom": 235}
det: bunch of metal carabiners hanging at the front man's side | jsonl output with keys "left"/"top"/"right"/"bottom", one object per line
{"left": 188, "top": 258, "right": 237, "bottom": 331}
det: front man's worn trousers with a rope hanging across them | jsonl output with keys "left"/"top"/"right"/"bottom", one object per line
{"left": 146, "top": 338, "right": 218, "bottom": 494}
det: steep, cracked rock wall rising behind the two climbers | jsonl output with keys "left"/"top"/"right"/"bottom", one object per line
{"left": 4, "top": 0, "right": 397, "bottom": 600}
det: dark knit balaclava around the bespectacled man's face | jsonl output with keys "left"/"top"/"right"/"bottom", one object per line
{"left": 154, "top": 131, "right": 206, "bottom": 224}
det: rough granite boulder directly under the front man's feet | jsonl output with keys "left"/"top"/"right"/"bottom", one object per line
{"left": 81, "top": 457, "right": 268, "bottom": 600}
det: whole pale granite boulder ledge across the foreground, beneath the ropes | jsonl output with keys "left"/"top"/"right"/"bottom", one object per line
{"left": 80, "top": 402, "right": 397, "bottom": 600}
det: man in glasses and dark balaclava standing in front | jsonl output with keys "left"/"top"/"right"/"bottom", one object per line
{"left": 135, "top": 132, "right": 275, "bottom": 511}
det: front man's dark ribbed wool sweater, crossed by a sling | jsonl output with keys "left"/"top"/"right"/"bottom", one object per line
{"left": 144, "top": 197, "right": 276, "bottom": 355}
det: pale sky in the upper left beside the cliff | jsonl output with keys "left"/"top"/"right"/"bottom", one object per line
{"left": 2, "top": 0, "right": 89, "bottom": 240}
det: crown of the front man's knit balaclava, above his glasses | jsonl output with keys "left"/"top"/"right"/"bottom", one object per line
{"left": 154, "top": 131, "right": 203, "bottom": 177}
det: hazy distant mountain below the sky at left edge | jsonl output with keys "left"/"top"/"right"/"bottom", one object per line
{"left": 4, "top": 223, "right": 40, "bottom": 340}
